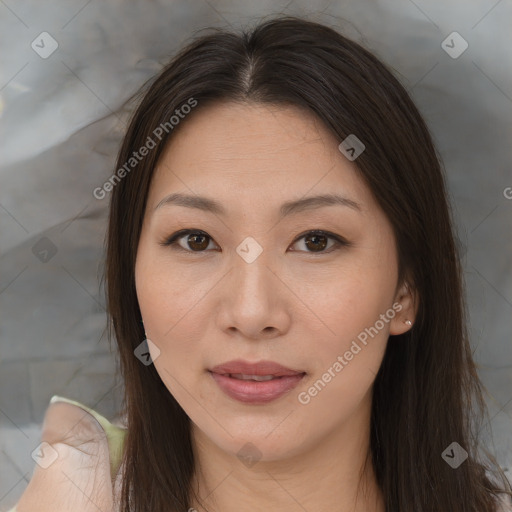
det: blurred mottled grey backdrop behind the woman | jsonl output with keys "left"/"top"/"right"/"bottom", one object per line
{"left": 0, "top": 0, "right": 512, "bottom": 510}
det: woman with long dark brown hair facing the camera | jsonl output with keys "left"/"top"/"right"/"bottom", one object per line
{"left": 12, "top": 14, "right": 512, "bottom": 512}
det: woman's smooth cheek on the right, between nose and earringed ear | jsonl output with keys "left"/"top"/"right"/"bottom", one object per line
{"left": 294, "top": 257, "right": 395, "bottom": 392}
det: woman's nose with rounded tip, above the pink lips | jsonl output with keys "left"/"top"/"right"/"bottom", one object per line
{"left": 218, "top": 246, "right": 291, "bottom": 340}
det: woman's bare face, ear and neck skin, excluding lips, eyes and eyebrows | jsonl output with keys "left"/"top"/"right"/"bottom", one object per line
{"left": 135, "top": 103, "right": 416, "bottom": 512}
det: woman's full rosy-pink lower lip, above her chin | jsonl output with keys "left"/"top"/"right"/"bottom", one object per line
{"left": 210, "top": 372, "right": 305, "bottom": 404}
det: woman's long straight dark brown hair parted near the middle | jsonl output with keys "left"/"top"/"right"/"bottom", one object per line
{"left": 105, "top": 17, "right": 511, "bottom": 512}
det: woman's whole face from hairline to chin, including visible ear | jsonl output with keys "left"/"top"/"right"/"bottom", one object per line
{"left": 135, "top": 103, "right": 414, "bottom": 460}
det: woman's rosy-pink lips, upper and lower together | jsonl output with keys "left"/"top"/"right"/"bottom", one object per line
{"left": 208, "top": 359, "right": 306, "bottom": 404}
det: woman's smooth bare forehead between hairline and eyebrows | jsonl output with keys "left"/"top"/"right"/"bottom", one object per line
{"left": 148, "top": 102, "right": 372, "bottom": 216}
